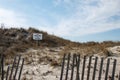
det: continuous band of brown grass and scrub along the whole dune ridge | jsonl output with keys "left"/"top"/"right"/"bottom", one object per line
{"left": 0, "top": 28, "right": 120, "bottom": 57}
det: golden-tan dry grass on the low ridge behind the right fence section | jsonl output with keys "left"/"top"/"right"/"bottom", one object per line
{"left": 60, "top": 41, "right": 120, "bottom": 56}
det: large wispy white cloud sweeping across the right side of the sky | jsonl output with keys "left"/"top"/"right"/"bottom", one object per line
{"left": 46, "top": 0, "right": 120, "bottom": 36}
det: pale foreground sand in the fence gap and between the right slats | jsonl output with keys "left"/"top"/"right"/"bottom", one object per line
{"left": 3, "top": 47, "right": 120, "bottom": 80}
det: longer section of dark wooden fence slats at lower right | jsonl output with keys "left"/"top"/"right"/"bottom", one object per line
{"left": 60, "top": 54, "right": 120, "bottom": 80}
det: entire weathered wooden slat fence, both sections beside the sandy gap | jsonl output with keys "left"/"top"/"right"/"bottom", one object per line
{"left": 0, "top": 54, "right": 120, "bottom": 80}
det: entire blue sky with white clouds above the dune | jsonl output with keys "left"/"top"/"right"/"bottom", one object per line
{"left": 0, "top": 0, "right": 120, "bottom": 42}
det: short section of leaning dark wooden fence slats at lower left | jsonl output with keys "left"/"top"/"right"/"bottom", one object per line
{"left": 0, "top": 55, "right": 24, "bottom": 80}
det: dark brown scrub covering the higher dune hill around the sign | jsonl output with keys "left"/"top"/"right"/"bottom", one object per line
{"left": 0, "top": 28, "right": 70, "bottom": 57}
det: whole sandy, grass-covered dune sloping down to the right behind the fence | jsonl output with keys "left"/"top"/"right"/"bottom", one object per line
{"left": 0, "top": 28, "right": 120, "bottom": 80}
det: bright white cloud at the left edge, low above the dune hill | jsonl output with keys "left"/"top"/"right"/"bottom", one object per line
{"left": 0, "top": 8, "right": 26, "bottom": 27}
